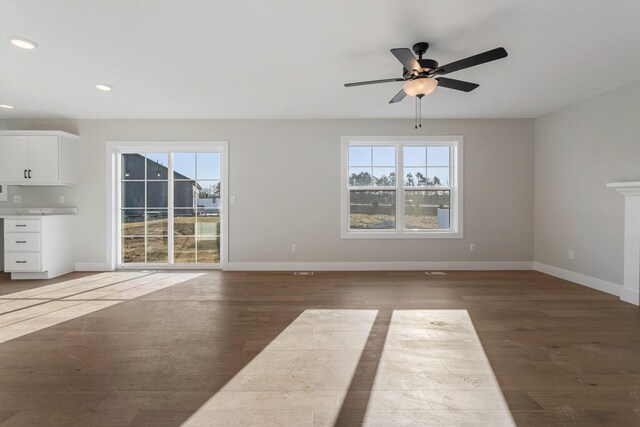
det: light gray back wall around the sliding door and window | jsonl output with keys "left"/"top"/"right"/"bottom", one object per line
{"left": 0, "top": 119, "right": 534, "bottom": 270}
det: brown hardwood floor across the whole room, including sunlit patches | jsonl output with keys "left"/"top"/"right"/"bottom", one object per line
{"left": 0, "top": 271, "right": 640, "bottom": 426}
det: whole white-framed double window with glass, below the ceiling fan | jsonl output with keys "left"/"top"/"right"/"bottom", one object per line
{"left": 341, "top": 136, "right": 462, "bottom": 239}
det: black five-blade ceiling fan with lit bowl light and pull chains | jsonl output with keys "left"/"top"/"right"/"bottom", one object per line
{"left": 344, "top": 42, "right": 508, "bottom": 129}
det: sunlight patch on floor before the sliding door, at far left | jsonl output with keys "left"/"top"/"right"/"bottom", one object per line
{"left": 0, "top": 271, "right": 204, "bottom": 343}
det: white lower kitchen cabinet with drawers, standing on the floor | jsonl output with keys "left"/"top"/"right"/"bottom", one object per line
{"left": 4, "top": 215, "right": 75, "bottom": 280}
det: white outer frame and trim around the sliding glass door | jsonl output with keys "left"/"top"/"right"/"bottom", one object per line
{"left": 106, "top": 141, "right": 229, "bottom": 270}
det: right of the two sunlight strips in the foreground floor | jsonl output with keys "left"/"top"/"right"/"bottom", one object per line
{"left": 364, "top": 310, "right": 515, "bottom": 426}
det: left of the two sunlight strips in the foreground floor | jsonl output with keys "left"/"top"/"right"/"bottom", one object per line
{"left": 183, "top": 310, "right": 377, "bottom": 426}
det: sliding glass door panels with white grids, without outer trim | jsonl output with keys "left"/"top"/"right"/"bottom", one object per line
{"left": 118, "top": 150, "right": 222, "bottom": 267}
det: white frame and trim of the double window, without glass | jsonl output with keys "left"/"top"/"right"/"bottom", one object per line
{"left": 340, "top": 135, "right": 464, "bottom": 239}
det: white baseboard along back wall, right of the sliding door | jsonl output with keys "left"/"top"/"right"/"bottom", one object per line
{"left": 226, "top": 261, "right": 533, "bottom": 271}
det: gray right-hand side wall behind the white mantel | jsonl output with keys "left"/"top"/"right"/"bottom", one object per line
{"left": 535, "top": 80, "right": 640, "bottom": 284}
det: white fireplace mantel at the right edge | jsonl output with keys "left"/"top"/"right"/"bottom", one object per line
{"left": 607, "top": 181, "right": 640, "bottom": 305}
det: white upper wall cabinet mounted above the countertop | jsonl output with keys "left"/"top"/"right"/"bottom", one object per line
{"left": 0, "top": 131, "right": 78, "bottom": 185}
